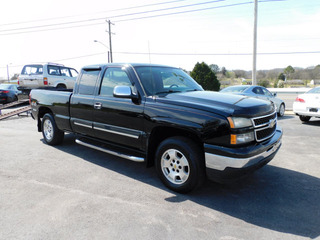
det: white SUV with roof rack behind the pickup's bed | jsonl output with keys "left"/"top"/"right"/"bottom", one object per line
{"left": 18, "top": 63, "right": 78, "bottom": 89}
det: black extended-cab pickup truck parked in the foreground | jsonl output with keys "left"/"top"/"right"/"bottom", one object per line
{"left": 30, "top": 64, "right": 282, "bottom": 192}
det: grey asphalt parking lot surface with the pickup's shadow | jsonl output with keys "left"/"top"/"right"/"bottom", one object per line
{"left": 0, "top": 115, "right": 320, "bottom": 240}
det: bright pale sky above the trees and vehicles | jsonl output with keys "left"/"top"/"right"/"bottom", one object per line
{"left": 0, "top": 0, "right": 320, "bottom": 79}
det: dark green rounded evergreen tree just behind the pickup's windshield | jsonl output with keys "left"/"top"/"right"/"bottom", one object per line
{"left": 190, "top": 62, "right": 220, "bottom": 91}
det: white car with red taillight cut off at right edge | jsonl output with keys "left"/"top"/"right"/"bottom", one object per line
{"left": 293, "top": 87, "right": 320, "bottom": 122}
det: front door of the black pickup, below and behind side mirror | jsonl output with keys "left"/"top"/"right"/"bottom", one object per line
{"left": 93, "top": 67, "right": 143, "bottom": 149}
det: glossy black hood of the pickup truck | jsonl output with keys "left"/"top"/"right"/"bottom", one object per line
{"left": 156, "top": 91, "right": 275, "bottom": 117}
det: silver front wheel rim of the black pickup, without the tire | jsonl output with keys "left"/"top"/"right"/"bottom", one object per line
{"left": 161, "top": 149, "right": 190, "bottom": 184}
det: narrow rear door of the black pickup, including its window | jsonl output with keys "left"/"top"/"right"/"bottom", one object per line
{"left": 70, "top": 67, "right": 101, "bottom": 136}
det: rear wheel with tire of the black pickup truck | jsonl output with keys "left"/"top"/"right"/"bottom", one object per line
{"left": 41, "top": 113, "right": 64, "bottom": 146}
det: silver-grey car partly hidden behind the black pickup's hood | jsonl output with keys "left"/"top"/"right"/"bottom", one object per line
{"left": 220, "top": 85, "right": 286, "bottom": 117}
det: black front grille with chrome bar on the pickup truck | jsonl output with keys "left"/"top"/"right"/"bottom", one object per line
{"left": 252, "top": 112, "right": 277, "bottom": 142}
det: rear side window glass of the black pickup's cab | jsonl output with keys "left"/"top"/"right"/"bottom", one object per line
{"left": 78, "top": 70, "right": 100, "bottom": 95}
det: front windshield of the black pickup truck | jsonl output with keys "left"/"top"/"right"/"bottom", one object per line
{"left": 135, "top": 66, "right": 203, "bottom": 96}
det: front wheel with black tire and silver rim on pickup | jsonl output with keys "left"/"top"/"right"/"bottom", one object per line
{"left": 155, "top": 137, "right": 206, "bottom": 193}
